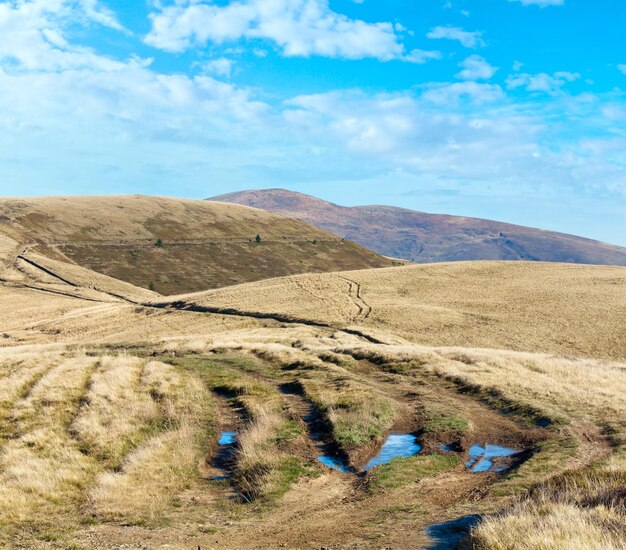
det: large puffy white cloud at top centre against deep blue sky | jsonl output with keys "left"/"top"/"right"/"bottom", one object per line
{"left": 145, "top": 0, "right": 434, "bottom": 63}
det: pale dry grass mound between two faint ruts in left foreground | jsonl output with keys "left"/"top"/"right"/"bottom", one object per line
{"left": 72, "top": 355, "right": 161, "bottom": 467}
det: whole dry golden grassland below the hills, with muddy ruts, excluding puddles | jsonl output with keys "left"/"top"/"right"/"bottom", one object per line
{"left": 0, "top": 207, "right": 626, "bottom": 550}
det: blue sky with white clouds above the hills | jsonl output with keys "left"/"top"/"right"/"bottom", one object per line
{"left": 0, "top": 0, "right": 626, "bottom": 246}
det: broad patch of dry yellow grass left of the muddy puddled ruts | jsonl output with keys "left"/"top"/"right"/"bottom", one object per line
{"left": 0, "top": 346, "right": 214, "bottom": 547}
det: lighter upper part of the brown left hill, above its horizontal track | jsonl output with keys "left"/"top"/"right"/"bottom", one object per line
{"left": 0, "top": 195, "right": 327, "bottom": 244}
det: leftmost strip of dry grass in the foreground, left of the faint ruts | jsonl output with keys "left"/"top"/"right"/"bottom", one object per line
{"left": 0, "top": 355, "right": 96, "bottom": 540}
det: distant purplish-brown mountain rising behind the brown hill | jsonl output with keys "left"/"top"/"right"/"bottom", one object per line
{"left": 211, "top": 189, "right": 626, "bottom": 266}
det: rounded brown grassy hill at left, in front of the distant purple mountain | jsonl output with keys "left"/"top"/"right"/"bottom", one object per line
{"left": 0, "top": 196, "right": 392, "bottom": 294}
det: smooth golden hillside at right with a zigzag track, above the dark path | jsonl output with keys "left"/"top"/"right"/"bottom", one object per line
{"left": 161, "top": 262, "right": 626, "bottom": 359}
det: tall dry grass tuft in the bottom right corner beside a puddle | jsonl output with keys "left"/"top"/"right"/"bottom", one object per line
{"left": 473, "top": 473, "right": 626, "bottom": 550}
